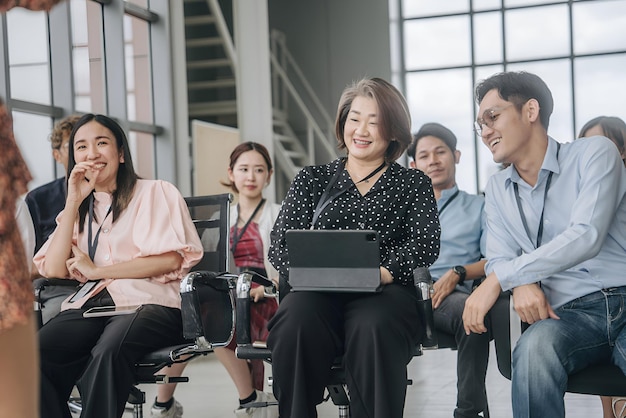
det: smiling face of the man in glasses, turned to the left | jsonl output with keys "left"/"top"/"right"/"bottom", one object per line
{"left": 478, "top": 89, "right": 539, "bottom": 164}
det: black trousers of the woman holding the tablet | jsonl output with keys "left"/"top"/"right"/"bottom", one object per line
{"left": 267, "top": 284, "right": 422, "bottom": 418}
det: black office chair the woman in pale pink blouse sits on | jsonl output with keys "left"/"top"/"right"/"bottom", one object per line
{"left": 128, "top": 193, "right": 235, "bottom": 418}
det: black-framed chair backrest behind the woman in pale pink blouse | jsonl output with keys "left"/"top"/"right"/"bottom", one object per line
{"left": 185, "top": 193, "right": 233, "bottom": 272}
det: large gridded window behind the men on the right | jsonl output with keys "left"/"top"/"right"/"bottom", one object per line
{"left": 396, "top": 0, "right": 626, "bottom": 192}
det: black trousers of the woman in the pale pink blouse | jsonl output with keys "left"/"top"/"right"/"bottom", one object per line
{"left": 39, "top": 305, "right": 184, "bottom": 418}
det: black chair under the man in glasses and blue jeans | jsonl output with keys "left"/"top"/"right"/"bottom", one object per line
{"left": 491, "top": 292, "right": 626, "bottom": 396}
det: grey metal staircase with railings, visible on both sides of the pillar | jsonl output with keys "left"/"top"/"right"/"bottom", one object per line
{"left": 184, "top": 0, "right": 337, "bottom": 196}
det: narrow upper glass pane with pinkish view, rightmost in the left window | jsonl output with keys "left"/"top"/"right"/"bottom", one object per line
{"left": 124, "top": 16, "right": 153, "bottom": 124}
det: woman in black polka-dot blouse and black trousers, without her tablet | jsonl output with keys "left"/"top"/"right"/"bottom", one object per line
{"left": 268, "top": 78, "right": 440, "bottom": 418}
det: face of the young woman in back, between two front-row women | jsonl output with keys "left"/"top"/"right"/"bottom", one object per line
{"left": 228, "top": 150, "right": 272, "bottom": 199}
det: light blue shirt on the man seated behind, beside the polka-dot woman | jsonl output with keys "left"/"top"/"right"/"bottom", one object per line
{"left": 429, "top": 185, "right": 487, "bottom": 293}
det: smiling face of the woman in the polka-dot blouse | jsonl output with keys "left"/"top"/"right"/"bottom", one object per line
{"left": 343, "top": 96, "right": 389, "bottom": 163}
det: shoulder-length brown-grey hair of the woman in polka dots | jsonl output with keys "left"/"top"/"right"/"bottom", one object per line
{"left": 335, "top": 77, "right": 412, "bottom": 162}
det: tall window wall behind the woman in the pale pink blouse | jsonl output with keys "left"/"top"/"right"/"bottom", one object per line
{"left": 0, "top": 0, "right": 179, "bottom": 189}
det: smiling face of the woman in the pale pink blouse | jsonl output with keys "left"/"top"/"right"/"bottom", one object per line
{"left": 73, "top": 120, "right": 124, "bottom": 192}
